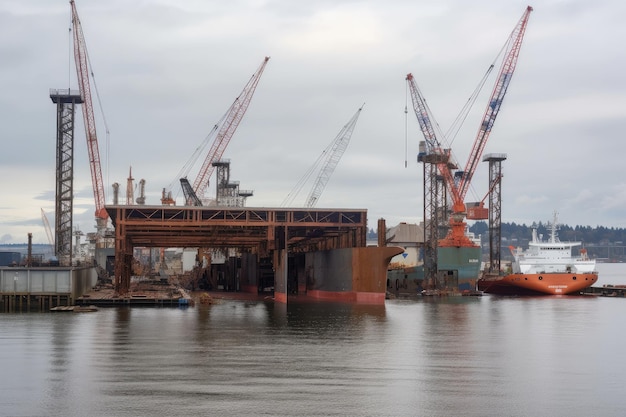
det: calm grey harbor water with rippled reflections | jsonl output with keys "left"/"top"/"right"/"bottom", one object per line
{"left": 0, "top": 264, "right": 626, "bottom": 417}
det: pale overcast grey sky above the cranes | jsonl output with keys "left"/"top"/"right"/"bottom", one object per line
{"left": 0, "top": 0, "right": 626, "bottom": 243}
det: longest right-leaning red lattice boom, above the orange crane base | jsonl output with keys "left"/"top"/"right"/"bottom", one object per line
{"left": 457, "top": 6, "right": 533, "bottom": 203}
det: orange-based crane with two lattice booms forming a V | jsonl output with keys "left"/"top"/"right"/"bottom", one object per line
{"left": 407, "top": 6, "right": 533, "bottom": 247}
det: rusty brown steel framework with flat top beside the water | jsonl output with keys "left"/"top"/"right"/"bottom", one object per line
{"left": 107, "top": 205, "right": 368, "bottom": 295}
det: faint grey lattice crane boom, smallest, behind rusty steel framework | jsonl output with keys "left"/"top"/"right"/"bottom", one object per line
{"left": 281, "top": 104, "right": 365, "bottom": 208}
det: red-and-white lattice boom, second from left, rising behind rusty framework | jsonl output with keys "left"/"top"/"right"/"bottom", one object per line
{"left": 193, "top": 56, "right": 270, "bottom": 199}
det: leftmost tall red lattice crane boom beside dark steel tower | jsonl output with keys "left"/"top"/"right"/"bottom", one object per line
{"left": 70, "top": 0, "right": 109, "bottom": 236}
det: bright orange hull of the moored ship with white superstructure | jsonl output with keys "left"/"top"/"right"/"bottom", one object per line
{"left": 492, "top": 272, "right": 598, "bottom": 295}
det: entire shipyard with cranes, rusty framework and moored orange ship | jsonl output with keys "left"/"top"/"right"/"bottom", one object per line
{"left": 0, "top": 1, "right": 620, "bottom": 311}
